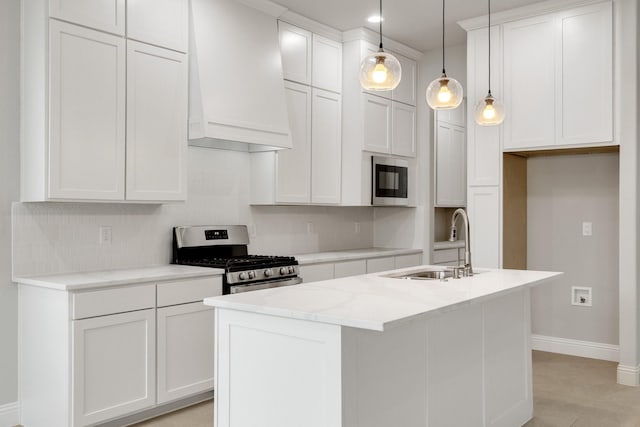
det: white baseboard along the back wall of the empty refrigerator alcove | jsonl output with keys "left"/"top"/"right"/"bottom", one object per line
{"left": 531, "top": 334, "right": 620, "bottom": 362}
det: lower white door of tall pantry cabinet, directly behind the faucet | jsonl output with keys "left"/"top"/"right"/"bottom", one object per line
{"left": 467, "top": 186, "right": 502, "bottom": 268}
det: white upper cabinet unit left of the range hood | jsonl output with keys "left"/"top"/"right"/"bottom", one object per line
{"left": 20, "top": 0, "right": 188, "bottom": 202}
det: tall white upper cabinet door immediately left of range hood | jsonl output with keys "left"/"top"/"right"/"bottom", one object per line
{"left": 126, "top": 41, "right": 188, "bottom": 201}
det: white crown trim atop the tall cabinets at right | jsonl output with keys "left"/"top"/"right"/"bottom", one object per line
{"left": 458, "top": 0, "right": 611, "bottom": 31}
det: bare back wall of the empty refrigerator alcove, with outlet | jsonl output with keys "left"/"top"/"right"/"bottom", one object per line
{"left": 527, "top": 153, "right": 619, "bottom": 344}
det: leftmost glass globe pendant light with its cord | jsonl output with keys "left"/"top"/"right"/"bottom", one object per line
{"left": 360, "top": 0, "right": 402, "bottom": 91}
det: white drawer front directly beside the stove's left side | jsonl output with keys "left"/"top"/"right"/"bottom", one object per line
{"left": 158, "top": 276, "right": 222, "bottom": 307}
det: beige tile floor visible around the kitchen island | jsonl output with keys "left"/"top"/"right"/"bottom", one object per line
{"left": 136, "top": 351, "right": 640, "bottom": 427}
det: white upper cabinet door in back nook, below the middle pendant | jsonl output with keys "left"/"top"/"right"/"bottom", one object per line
{"left": 435, "top": 121, "right": 467, "bottom": 207}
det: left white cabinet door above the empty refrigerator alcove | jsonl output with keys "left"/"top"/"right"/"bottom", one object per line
{"left": 504, "top": 15, "right": 556, "bottom": 150}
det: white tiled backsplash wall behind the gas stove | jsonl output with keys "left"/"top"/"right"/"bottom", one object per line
{"left": 13, "top": 147, "right": 373, "bottom": 276}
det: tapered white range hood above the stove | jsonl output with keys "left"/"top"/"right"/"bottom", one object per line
{"left": 189, "top": 0, "right": 292, "bottom": 151}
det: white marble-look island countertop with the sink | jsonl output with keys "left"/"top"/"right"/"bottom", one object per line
{"left": 204, "top": 266, "right": 562, "bottom": 331}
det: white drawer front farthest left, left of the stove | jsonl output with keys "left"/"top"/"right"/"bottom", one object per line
{"left": 71, "top": 285, "right": 156, "bottom": 319}
